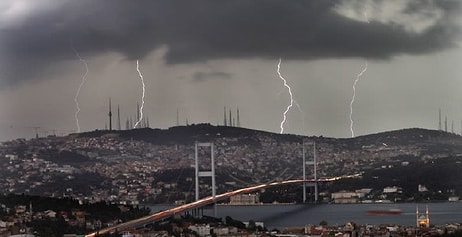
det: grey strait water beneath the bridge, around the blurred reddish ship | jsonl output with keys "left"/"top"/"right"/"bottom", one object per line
{"left": 150, "top": 202, "right": 462, "bottom": 229}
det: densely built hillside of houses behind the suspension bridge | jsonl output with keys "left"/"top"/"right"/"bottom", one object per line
{"left": 0, "top": 125, "right": 461, "bottom": 205}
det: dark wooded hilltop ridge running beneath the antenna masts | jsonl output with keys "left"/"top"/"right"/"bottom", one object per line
{"left": 69, "top": 123, "right": 462, "bottom": 145}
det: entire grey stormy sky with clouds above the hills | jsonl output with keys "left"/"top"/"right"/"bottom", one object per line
{"left": 0, "top": 0, "right": 462, "bottom": 141}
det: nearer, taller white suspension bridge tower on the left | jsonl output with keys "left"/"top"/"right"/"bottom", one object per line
{"left": 195, "top": 142, "right": 217, "bottom": 216}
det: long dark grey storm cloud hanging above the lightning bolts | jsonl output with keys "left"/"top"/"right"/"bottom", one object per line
{"left": 0, "top": 0, "right": 460, "bottom": 87}
